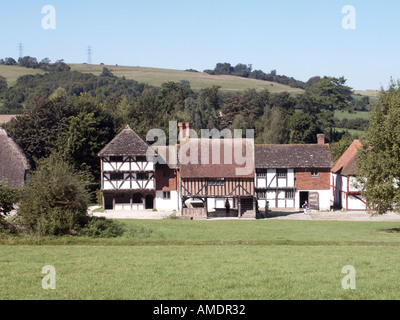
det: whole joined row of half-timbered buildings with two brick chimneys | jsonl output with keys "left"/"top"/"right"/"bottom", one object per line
{"left": 99, "top": 123, "right": 332, "bottom": 218}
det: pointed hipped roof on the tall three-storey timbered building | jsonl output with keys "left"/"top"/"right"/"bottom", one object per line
{"left": 98, "top": 126, "right": 150, "bottom": 157}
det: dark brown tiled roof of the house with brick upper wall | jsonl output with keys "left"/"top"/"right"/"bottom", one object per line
{"left": 255, "top": 144, "right": 333, "bottom": 169}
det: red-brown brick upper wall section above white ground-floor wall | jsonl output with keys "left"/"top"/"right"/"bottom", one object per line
{"left": 295, "top": 169, "right": 331, "bottom": 190}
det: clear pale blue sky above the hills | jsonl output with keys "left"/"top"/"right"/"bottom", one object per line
{"left": 0, "top": 0, "right": 400, "bottom": 90}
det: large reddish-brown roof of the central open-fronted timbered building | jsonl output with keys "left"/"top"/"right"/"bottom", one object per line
{"left": 179, "top": 139, "right": 255, "bottom": 178}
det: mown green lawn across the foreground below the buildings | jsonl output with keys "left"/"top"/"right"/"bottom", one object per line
{"left": 0, "top": 219, "right": 400, "bottom": 300}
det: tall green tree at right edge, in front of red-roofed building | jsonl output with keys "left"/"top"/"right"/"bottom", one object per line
{"left": 357, "top": 82, "right": 400, "bottom": 214}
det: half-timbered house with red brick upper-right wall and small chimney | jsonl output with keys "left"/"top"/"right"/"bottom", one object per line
{"left": 255, "top": 135, "right": 332, "bottom": 210}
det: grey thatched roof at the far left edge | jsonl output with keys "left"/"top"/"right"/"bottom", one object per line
{"left": 0, "top": 128, "right": 31, "bottom": 188}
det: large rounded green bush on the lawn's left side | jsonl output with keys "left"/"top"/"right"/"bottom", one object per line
{"left": 18, "top": 154, "right": 90, "bottom": 236}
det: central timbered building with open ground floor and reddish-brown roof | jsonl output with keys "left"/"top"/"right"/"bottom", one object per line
{"left": 179, "top": 139, "right": 255, "bottom": 218}
